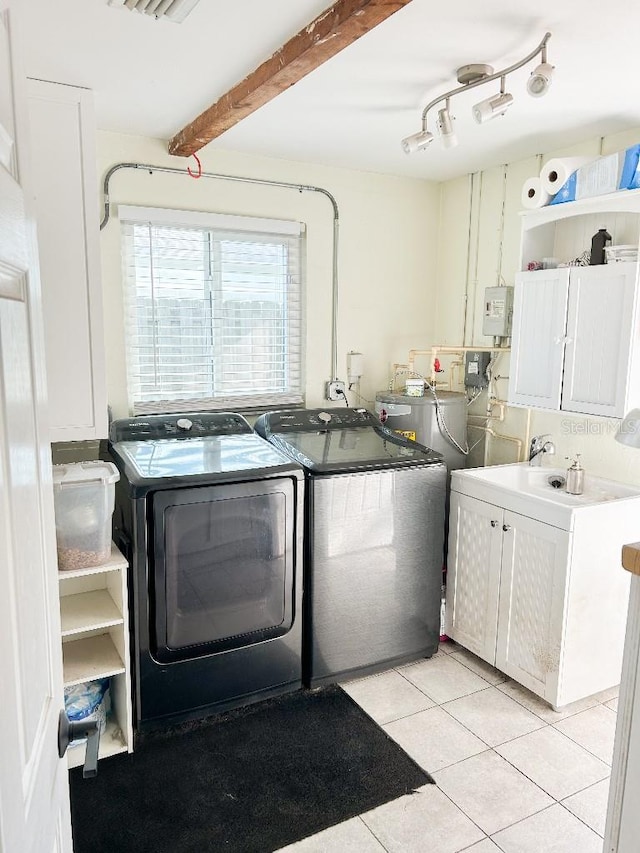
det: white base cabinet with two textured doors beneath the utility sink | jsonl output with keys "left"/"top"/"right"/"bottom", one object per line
{"left": 445, "top": 472, "right": 640, "bottom": 708}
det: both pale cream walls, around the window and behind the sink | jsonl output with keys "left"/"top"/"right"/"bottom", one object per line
{"left": 98, "top": 130, "right": 640, "bottom": 483}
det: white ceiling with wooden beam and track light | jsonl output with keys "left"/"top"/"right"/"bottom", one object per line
{"left": 19, "top": 0, "right": 640, "bottom": 180}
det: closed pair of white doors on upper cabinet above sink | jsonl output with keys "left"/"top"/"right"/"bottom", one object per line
{"left": 509, "top": 263, "right": 640, "bottom": 418}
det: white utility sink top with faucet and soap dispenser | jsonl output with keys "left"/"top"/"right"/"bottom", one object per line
{"left": 452, "top": 462, "right": 640, "bottom": 529}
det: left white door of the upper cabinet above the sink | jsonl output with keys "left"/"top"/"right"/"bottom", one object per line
{"left": 509, "top": 269, "right": 569, "bottom": 409}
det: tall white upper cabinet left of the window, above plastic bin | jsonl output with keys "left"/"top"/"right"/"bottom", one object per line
{"left": 28, "top": 80, "right": 107, "bottom": 441}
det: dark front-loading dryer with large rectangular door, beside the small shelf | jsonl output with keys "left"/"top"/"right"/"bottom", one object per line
{"left": 109, "top": 413, "right": 304, "bottom": 729}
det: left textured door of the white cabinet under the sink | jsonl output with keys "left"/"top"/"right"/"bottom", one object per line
{"left": 445, "top": 492, "right": 503, "bottom": 664}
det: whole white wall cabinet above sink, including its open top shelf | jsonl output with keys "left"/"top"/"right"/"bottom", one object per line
{"left": 509, "top": 190, "right": 640, "bottom": 418}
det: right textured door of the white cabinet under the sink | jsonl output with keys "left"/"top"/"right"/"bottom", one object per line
{"left": 496, "top": 511, "right": 570, "bottom": 704}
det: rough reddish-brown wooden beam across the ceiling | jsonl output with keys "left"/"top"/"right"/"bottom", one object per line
{"left": 169, "top": 0, "right": 411, "bottom": 157}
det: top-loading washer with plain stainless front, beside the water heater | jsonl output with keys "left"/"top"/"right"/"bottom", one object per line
{"left": 254, "top": 408, "right": 447, "bottom": 685}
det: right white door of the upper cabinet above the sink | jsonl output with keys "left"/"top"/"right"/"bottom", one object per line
{"left": 562, "top": 263, "right": 637, "bottom": 418}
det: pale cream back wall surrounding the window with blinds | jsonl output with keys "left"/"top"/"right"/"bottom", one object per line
{"left": 98, "top": 132, "right": 439, "bottom": 417}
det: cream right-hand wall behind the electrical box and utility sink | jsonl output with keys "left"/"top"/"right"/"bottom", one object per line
{"left": 435, "top": 129, "right": 640, "bottom": 484}
